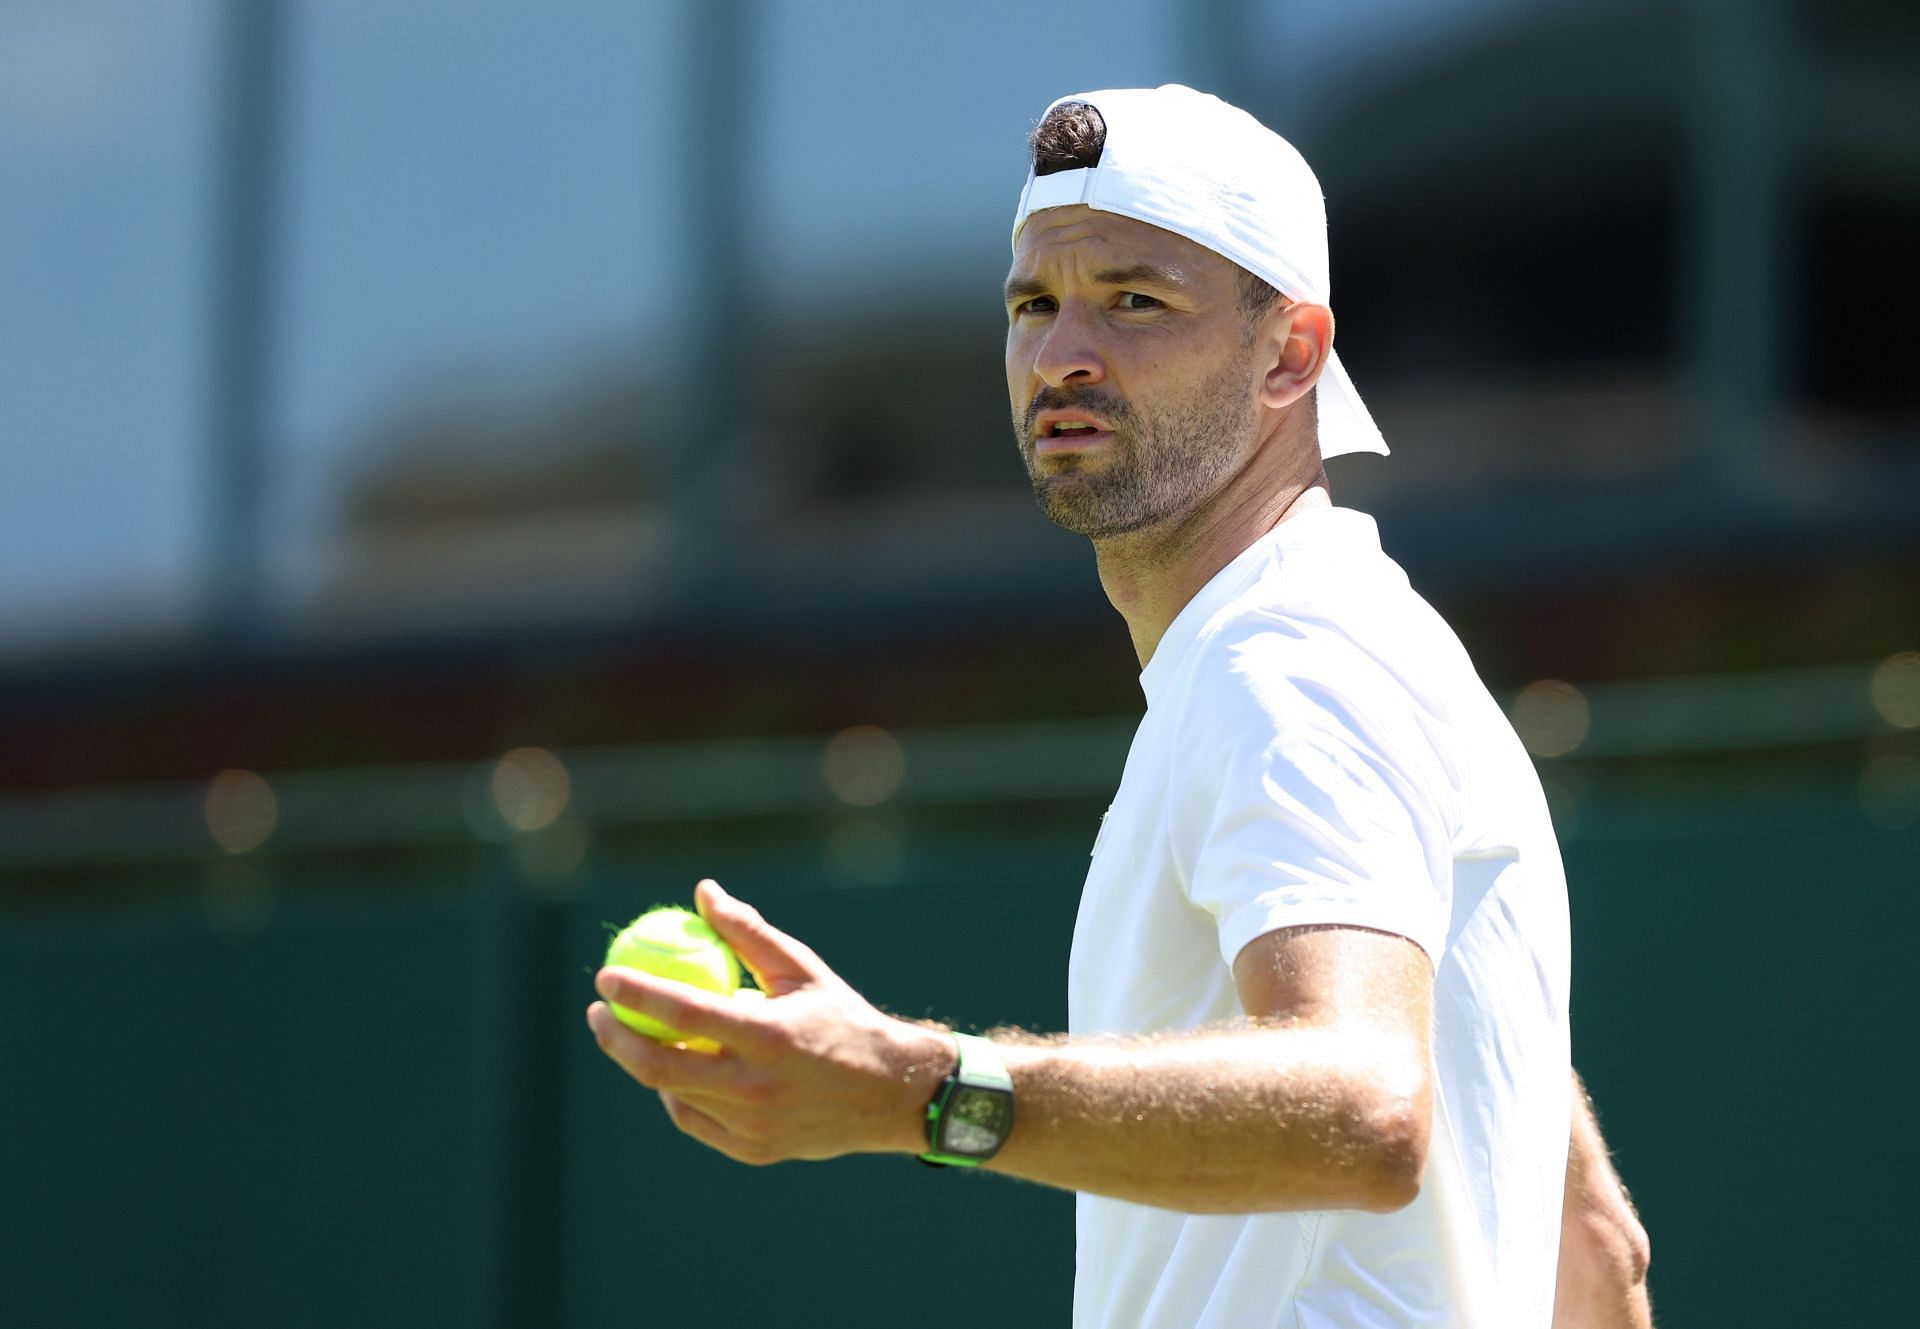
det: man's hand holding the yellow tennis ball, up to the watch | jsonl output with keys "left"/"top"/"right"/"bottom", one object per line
{"left": 588, "top": 882, "right": 954, "bottom": 1164}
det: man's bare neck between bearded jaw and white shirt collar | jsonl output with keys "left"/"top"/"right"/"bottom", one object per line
{"left": 1094, "top": 449, "right": 1332, "bottom": 668}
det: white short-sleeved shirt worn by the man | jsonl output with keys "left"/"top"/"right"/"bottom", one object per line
{"left": 1069, "top": 507, "right": 1572, "bottom": 1329}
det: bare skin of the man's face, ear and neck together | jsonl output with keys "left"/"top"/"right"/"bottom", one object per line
{"left": 1006, "top": 205, "right": 1332, "bottom": 665}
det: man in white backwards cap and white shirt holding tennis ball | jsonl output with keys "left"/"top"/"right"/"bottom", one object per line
{"left": 588, "top": 86, "right": 1638, "bottom": 1329}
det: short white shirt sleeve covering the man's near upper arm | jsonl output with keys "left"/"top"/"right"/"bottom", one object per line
{"left": 1167, "top": 630, "right": 1452, "bottom": 966}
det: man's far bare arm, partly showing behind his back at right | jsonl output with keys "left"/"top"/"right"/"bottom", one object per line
{"left": 1553, "top": 1074, "right": 1653, "bottom": 1329}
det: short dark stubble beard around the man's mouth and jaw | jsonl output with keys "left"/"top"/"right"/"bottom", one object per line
{"left": 1014, "top": 365, "right": 1256, "bottom": 540}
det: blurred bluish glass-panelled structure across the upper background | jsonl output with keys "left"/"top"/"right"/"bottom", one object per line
{"left": 0, "top": 0, "right": 1920, "bottom": 668}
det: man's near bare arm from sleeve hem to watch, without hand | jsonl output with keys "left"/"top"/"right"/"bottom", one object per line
{"left": 991, "top": 928, "right": 1432, "bottom": 1214}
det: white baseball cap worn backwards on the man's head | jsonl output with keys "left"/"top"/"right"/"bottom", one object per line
{"left": 1014, "top": 83, "right": 1386, "bottom": 457}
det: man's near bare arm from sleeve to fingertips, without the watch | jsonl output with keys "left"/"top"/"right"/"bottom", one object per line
{"left": 588, "top": 883, "right": 1432, "bottom": 1212}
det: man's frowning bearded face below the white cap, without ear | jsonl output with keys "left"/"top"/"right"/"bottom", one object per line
{"left": 1006, "top": 207, "right": 1260, "bottom": 538}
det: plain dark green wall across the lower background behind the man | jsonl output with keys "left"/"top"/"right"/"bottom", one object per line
{"left": 0, "top": 780, "right": 1920, "bottom": 1329}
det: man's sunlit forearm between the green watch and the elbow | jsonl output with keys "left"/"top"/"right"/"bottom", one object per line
{"left": 975, "top": 1026, "right": 1430, "bottom": 1214}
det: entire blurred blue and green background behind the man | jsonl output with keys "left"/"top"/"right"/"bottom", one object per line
{"left": 0, "top": 0, "right": 1920, "bottom": 1329}
